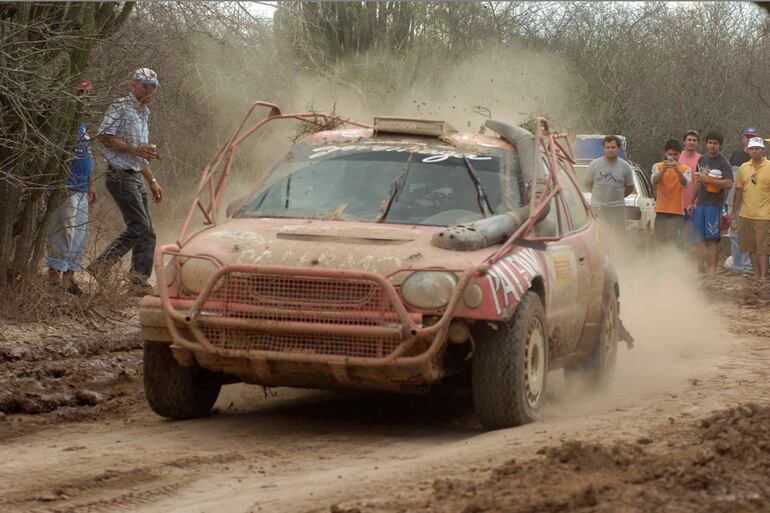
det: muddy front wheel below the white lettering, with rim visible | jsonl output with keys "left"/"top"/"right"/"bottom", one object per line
{"left": 472, "top": 291, "right": 548, "bottom": 429}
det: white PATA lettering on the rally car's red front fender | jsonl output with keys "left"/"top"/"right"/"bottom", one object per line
{"left": 486, "top": 248, "right": 543, "bottom": 316}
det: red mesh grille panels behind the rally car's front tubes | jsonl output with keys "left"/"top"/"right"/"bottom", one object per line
{"left": 197, "top": 272, "right": 401, "bottom": 358}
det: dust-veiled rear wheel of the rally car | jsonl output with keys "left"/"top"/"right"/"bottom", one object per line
{"left": 564, "top": 292, "right": 620, "bottom": 390}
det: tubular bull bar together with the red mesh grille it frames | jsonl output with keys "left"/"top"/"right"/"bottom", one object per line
{"left": 151, "top": 244, "right": 485, "bottom": 386}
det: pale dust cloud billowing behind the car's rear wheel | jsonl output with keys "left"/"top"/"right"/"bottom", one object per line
{"left": 548, "top": 244, "right": 733, "bottom": 417}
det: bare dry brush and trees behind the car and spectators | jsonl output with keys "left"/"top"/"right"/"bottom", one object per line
{"left": 0, "top": 2, "right": 770, "bottom": 298}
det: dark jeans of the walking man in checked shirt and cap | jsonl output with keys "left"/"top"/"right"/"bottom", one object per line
{"left": 92, "top": 170, "right": 155, "bottom": 283}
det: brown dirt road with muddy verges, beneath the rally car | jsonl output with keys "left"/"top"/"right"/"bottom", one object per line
{"left": 0, "top": 272, "right": 770, "bottom": 513}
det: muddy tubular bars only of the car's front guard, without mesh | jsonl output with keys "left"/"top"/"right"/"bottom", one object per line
{"left": 152, "top": 245, "right": 481, "bottom": 381}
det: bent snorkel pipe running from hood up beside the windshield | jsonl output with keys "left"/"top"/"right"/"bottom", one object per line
{"left": 431, "top": 119, "right": 548, "bottom": 251}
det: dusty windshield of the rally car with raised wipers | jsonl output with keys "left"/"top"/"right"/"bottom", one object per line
{"left": 235, "top": 140, "right": 521, "bottom": 226}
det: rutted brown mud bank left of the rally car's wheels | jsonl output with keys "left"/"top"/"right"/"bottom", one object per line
{"left": 0, "top": 310, "right": 141, "bottom": 439}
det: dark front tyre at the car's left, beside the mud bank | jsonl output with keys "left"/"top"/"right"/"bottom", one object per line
{"left": 144, "top": 342, "right": 222, "bottom": 419}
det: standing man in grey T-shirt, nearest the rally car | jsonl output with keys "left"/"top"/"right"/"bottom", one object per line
{"left": 584, "top": 135, "right": 634, "bottom": 240}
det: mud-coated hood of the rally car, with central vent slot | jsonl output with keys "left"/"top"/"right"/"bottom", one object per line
{"left": 182, "top": 218, "right": 496, "bottom": 281}
